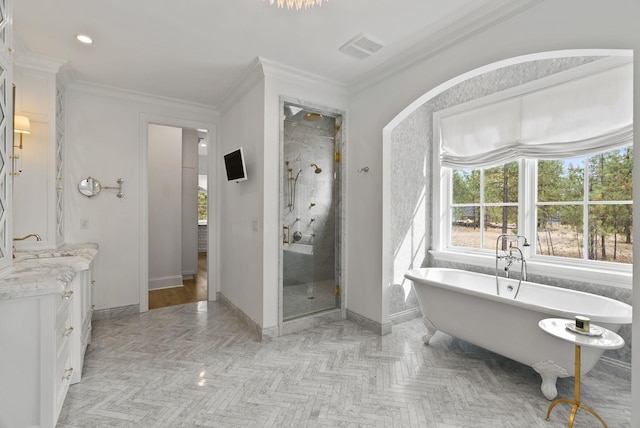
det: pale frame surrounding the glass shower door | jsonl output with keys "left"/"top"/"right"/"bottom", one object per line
{"left": 278, "top": 97, "right": 347, "bottom": 335}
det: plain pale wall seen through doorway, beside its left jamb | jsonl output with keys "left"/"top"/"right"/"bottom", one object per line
{"left": 148, "top": 124, "right": 182, "bottom": 290}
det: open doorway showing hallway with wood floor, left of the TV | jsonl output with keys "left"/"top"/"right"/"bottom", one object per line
{"left": 147, "top": 124, "right": 208, "bottom": 309}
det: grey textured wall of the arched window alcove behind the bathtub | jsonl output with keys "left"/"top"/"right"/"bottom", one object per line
{"left": 389, "top": 53, "right": 631, "bottom": 363}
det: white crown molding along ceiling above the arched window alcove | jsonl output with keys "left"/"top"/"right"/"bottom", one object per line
{"left": 349, "top": 0, "right": 544, "bottom": 96}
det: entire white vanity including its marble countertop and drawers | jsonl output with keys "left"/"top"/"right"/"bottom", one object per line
{"left": 0, "top": 247, "right": 95, "bottom": 428}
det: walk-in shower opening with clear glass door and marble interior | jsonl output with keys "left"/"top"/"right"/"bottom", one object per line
{"left": 281, "top": 102, "right": 342, "bottom": 322}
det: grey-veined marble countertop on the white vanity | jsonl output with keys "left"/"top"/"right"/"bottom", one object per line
{"left": 0, "top": 244, "right": 98, "bottom": 300}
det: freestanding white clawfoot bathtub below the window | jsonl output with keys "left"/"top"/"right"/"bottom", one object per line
{"left": 405, "top": 268, "right": 631, "bottom": 400}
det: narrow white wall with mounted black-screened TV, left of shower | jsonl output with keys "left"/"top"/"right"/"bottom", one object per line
{"left": 216, "top": 80, "right": 265, "bottom": 327}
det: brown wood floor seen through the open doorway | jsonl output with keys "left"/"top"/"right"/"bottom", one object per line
{"left": 149, "top": 253, "right": 207, "bottom": 309}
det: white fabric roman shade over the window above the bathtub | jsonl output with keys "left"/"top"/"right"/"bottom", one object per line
{"left": 439, "top": 64, "right": 633, "bottom": 168}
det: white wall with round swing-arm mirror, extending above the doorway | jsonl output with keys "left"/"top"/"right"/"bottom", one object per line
{"left": 64, "top": 83, "right": 217, "bottom": 310}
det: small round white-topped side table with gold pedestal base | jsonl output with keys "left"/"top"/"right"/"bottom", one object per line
{"left": 538, "top": 318, "right": 624, "bottom": 428}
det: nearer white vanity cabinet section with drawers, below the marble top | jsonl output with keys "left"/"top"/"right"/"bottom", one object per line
{"left": 0, "top": 276, "right": 78, "bottom": 428}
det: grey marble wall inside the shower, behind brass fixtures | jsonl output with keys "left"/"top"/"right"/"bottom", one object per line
{"left": 282, "top": 110, "right": 339, "bottom": 286}
